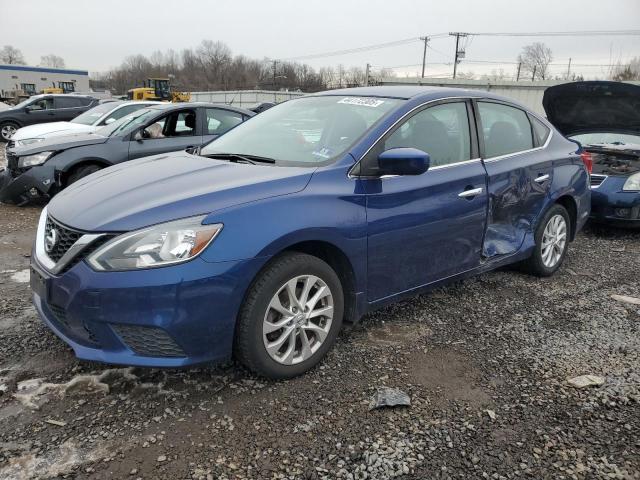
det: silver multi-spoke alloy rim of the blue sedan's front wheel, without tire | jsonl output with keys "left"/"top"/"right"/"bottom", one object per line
{"left": 262, "top": 275, "right": 333, "bottom": 365}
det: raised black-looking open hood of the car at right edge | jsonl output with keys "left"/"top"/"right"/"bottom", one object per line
{"left": 542, "top": 82, "right": 640, "bottom": 136}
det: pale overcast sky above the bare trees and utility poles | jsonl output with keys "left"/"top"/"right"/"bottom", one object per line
{"left": 0, "top": 0, "right": 640, "bottom": 77}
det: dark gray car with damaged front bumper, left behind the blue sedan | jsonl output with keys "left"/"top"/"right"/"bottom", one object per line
{"left": 0, "top": 103, "right": 255, "bottom": 205}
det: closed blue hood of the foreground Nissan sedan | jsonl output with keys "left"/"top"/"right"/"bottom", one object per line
{"left": 49, "top": 152, "right": 315, "bottom": 232}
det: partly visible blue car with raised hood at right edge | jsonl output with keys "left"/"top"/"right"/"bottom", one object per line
{"left": 543, "top": 81, "right": 640, "bottom": 227}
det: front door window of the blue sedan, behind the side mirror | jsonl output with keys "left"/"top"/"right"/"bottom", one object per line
{"left": 376, "top": 102, "right": 471, "bottom": 167}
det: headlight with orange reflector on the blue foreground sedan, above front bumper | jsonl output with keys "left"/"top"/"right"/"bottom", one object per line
{"left": 87, "top": 216, "right": 222, "bottom": 271}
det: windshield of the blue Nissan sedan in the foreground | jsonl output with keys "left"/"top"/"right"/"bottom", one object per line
{"left": 201, "top": 96, "right": 402, "bottom": 167}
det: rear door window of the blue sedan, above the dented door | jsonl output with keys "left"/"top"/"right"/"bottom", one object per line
{"left": 478, "top": 102, "right": 533, "bottom": 158}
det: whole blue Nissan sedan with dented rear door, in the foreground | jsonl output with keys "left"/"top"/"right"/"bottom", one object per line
{"left": 31, "top": 87, "right": 590, "bottom": 378}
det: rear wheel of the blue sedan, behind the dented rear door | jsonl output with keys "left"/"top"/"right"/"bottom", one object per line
{"left": 522, "top": 204, "right": 571, "bottom": 277}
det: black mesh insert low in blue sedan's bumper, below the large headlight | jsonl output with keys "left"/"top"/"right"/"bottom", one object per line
{"left": 111, "top": 324, "right": 186, "bottom": 357}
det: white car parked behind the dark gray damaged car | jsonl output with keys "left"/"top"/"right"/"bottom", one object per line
{"left": 11, "top": 101, "right": 162, "bottom": 147}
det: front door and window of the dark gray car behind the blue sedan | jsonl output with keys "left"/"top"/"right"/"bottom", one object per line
{"left": 129, "top": 108, "right": 203, "bottom": 160}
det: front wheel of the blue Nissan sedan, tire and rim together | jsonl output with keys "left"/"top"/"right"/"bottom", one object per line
{"left": 234, "top": 252, "right": 344, "bottom": 379}
